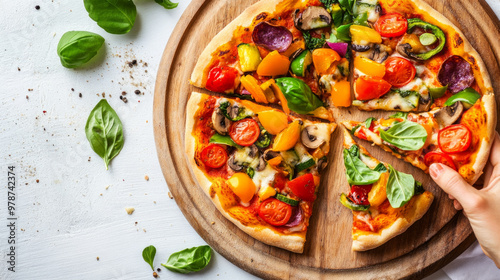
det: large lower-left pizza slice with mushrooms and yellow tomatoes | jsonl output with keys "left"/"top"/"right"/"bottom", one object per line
{"left": 185, "top": 92, "right": 336, "bottom": 253}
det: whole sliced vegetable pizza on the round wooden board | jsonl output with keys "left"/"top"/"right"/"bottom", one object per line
{"left": 186, "top": 0, "right": 496, "bottom": 252}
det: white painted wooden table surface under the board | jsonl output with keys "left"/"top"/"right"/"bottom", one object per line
{"left": 0, "top": 0, "right": 500, "bottom": 279}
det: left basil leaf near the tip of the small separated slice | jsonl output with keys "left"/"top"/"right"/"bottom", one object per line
{"left": 344, "top": 149, "right": 380, "bottom": 185}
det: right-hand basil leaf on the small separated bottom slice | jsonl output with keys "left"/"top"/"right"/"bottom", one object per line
{"left": 386, "top": 165, "right": 415, "bottom": 208}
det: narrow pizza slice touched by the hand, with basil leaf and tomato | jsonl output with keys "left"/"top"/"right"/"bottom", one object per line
{"left": 342, "top": 90, "right": 496, "bottom": 184}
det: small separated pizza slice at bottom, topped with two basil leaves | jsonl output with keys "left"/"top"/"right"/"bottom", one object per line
{"left": 340, "top": 130, "right": 434, "bottom": 251}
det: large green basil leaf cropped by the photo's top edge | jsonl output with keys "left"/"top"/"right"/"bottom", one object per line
{"left": 83, "top": 0, "right": 137, "bottom": 34}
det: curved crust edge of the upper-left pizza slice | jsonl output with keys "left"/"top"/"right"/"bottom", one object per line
{"left": 190, "top": 0, "right": 294, "bottom": 88}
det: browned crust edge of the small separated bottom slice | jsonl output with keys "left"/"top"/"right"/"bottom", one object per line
{"left": 352, "top": 191, "right": 434, "bottom": 251}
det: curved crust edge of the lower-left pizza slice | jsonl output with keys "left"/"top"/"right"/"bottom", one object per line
{"left": 185, "top": 92, "right": 306, "bottom": 253}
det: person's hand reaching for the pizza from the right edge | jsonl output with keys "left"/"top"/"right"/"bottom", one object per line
{"left": 430, "top": 133, "right": 500, "bottom": 268}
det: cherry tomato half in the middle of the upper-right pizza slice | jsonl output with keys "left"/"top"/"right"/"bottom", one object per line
{"left": 384, "top": 57, "right": 417, "bottom": 87}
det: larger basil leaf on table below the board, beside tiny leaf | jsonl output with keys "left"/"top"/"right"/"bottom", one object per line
{"left": 161, "top": 245, "right": 212, "bottom": 274}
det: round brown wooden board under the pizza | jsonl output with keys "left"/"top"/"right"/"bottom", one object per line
{"left": 154, "top": 0, "right": 500, "bottom": 279}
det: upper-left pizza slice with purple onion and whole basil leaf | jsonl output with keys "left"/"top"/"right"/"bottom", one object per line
{"left": 191, "top": 0, "right": 375, "bottom": 121}
